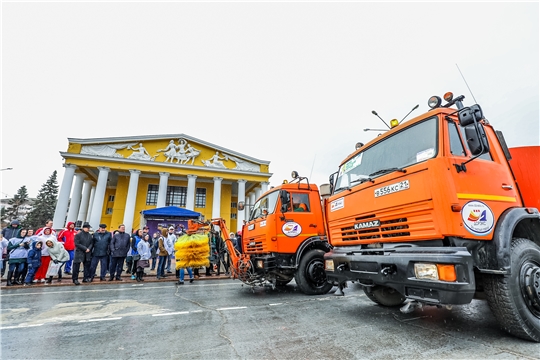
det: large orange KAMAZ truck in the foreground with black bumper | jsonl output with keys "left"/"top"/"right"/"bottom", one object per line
{"left": 324, "top": 93, "right": 540, "bottom": 342}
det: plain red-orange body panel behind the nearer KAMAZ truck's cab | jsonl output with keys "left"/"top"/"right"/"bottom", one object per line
{"left": 509, "top": 146, "right": 540, "bottom": 209}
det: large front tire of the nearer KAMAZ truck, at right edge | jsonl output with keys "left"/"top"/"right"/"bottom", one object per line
{"left": 483, "top": 238, "right": 540, "bottom": 342}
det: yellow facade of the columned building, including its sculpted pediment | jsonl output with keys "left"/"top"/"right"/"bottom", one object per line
{"left": 55, "top": 134, "right": 271, "bottom": 229}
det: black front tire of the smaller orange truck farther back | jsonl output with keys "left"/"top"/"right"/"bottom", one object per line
{"left": 294, "top": 249, "right": 333, "bottom": 295}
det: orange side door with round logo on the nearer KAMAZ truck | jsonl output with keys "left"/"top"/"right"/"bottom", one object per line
{"left": 447, "top": 122, "right": 520, "bottom": 239}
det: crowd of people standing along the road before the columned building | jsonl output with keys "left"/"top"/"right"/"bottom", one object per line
{"left": 0, "top": 220, "right": 237, "bottom": 286}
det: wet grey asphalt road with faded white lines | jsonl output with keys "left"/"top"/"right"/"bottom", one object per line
{"left": 0, "top": 279, "right": 540, "bottom": 359}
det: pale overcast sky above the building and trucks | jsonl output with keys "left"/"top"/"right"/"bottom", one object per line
{"left": 0, "top": 1, "right": 540, "bottom": 198}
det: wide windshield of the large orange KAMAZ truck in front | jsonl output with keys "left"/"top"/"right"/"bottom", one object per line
{"left": 335, "top": 117, "right": 437, "bottom": 191}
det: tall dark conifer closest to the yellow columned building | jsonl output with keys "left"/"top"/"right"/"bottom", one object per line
{"left": 24, "top": 170, "right": 58, "bottom": 229}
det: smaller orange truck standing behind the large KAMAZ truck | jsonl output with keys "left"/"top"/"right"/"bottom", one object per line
{"left": 240, "top": 172, "right": 332, "bottom": 295}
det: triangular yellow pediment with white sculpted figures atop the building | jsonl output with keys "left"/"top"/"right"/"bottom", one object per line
{"left": 68, "top": 134, "right": 270, "bottom": 172}
